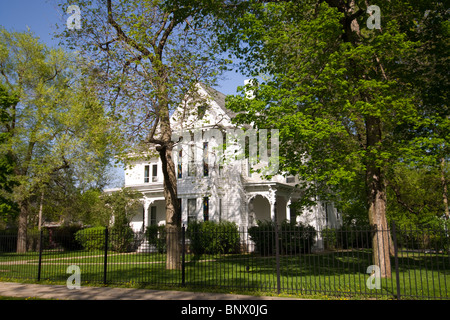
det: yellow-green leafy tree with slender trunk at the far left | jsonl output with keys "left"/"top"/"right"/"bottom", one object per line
{"left": 0, "top": 29, "right": 115, "bottom": 252}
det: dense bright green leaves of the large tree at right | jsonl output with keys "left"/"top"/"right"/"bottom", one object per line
{"left": 216, "top": 1, "right": 449, "bottom": 221}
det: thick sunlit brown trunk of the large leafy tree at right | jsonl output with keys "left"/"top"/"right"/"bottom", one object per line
{"left": 366, "top": 116, "right": 391, "bottom": 278}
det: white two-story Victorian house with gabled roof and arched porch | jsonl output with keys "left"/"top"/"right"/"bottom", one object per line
{"left": 119, "top": 86, "right": 340, "bottom": 250}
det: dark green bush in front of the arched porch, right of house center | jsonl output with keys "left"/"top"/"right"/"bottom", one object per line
{"left": 248, "top": 221, "right": 316, "bottom": 256}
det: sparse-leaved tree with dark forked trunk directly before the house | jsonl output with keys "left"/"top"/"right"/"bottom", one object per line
{"left": 56, "top": 0, "right": 230, "bottom": 269}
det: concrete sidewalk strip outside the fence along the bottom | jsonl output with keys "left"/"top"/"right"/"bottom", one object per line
{"left": 0, "top": 282, "right": 299, "bottom": 301}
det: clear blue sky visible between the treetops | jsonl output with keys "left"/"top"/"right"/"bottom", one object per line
{"left": 0, "top": 0, "right": 245, "bottom": 94}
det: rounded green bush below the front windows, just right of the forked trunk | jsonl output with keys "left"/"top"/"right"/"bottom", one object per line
{"left": 186, "top": 221, "right": 240, "bottom": 255}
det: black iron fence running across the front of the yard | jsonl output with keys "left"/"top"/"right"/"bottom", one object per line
{"left": 0, "top": 222, "right": 450, "bottom": 299}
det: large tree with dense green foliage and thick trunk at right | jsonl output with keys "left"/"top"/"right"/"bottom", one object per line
{"left": 202, "top": 0, "right": 444, "bottom": 277}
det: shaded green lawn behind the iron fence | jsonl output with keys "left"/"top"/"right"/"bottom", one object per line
{"left": 0, "top": 249, "right": 450, "bottom": 299}
